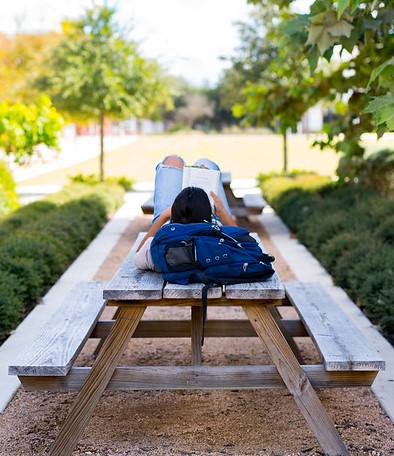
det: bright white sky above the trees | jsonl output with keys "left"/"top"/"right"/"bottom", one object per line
{"left": 0, "top": 0, "right": 255, "bottom": 85}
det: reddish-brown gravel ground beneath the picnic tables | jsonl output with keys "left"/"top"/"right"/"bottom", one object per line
{"left": 0, "top": 216, "right": 394, "bottom": 456}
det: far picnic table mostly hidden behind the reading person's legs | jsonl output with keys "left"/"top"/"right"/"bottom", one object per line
{"left": 141, "top": 172, "right": 266, "bottom": 218}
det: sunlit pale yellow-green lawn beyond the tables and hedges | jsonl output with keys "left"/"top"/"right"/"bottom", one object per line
{"left": 18, "top": 133, "right": 364, "bottom": 185}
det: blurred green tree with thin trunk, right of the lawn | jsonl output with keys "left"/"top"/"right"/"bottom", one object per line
{"left": 225, "top": 1, "right": 326, "bottom": 172}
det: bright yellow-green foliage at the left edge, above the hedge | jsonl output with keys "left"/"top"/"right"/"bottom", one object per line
{"left": 0, "top": 95, "right": 63, "bottom": 164}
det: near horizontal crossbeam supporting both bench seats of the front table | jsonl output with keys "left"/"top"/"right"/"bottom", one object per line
{"left": 20, "top": 365, "right": 377, "bottom": 391}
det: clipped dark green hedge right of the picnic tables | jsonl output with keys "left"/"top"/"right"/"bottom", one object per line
{"left": 261, "top": 175, "right": 394, "bottom": 343}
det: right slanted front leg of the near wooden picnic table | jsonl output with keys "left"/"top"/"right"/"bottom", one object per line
{"left": 243, "top": 304, "right": 349, "bottom": 455}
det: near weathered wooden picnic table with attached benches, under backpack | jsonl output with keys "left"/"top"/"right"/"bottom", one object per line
{"left": 9, "top": 233, "right": 385, "bottom": 455}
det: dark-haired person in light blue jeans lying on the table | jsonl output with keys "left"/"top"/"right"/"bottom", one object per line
{"left": 134, "top": 155, "right": 237, "bottom": 271}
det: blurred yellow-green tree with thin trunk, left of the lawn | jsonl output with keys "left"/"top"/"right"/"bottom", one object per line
{"left": 38, "top": 6, "right": 171, "bottom": 180}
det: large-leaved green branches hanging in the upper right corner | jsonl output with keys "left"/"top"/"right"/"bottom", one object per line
{"left": 249, "top": 0, "right": 394, "bottom": 165}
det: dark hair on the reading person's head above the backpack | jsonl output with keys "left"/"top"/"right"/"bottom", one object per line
{"left": 171, "top": 187, "right": 212, "bottom": 224}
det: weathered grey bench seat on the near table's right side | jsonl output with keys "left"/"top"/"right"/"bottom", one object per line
{"left": 285, "top": 282, "right": 385, "bottom": 371}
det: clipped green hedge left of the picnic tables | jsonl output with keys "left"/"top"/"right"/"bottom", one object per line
{"left": 0, "top": 184, "right": 124, "bottom": 339}
